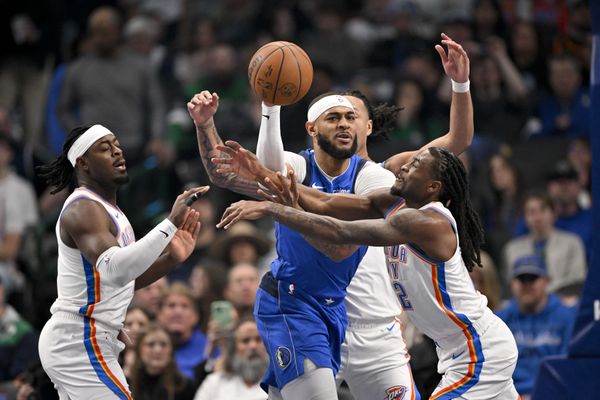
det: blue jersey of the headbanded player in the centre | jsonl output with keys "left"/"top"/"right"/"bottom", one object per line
{"left": 271, "top": 149, "right": 367, "bottom": 302}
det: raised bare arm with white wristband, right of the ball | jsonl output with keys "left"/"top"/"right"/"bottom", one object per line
{"left": 385, "top": 33, "right": 475, "bottom": 171}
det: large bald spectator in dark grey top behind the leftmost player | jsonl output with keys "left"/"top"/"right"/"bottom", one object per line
{"left": 59, "top": 7, "right": 166, "bottom": 164}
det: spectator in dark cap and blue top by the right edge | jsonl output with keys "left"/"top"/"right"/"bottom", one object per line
{"left": 548, "top": 161, "right": 593, "bottom": 260}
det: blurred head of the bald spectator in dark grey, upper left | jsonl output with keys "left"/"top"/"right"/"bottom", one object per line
{"left": 89, "top": 7, "right": 121, "bottom": 54}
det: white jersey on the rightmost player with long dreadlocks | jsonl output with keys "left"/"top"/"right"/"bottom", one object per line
{"left": 385, "top": 202, "right": 487, "bottom": 340}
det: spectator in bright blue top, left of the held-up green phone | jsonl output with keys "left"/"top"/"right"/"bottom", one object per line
{"left": 157, "top": 282, "right": 206, "bottom": 379}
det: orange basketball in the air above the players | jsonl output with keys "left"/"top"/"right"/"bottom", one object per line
{"left": 248, "top": 41, "right": 313, "bottom": 106}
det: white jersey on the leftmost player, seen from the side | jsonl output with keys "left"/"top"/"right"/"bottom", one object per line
{"left": 50, "top": 187, "right": 135, "bottom": 330}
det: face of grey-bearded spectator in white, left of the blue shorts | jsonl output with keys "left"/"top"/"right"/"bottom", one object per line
{"left": 230, "top": 321, "right": 269, "bottom": 384}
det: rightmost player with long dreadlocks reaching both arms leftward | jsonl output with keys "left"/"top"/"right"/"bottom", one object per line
{"left": 217, "top": 147, "right": 518, "bottom": 400}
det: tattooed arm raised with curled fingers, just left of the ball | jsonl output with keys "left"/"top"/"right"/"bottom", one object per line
{"left": 187, "top": 90, "right": 258, "bottom": 198}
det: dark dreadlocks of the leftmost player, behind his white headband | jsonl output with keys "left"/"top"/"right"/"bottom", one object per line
{"left": 35, "top": 126, "right": 90, "bottom": 194}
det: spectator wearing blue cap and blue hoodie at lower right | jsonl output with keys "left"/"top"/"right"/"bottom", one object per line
{"left": 496, "top": 255, "right": 575, "bottom": 399}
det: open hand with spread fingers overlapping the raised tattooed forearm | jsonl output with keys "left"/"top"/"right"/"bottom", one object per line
{"left": 211, "top": 140, "right": 265, "bottom": 181}
